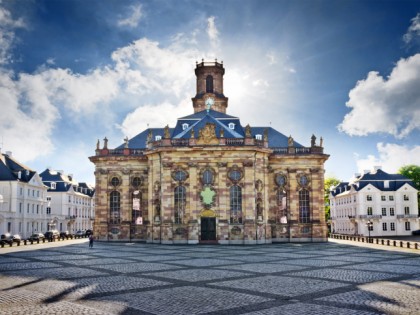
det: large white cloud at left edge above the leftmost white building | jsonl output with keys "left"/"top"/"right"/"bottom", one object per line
{"left": 0, "top": 72, "right": 60, "bottom": 158}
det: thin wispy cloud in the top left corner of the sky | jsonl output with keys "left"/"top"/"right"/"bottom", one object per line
{"left": 0, "top": 2, "right": 26, "bottom": 65}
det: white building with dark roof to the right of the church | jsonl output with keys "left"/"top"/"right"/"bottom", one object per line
{"left": 330, "top": 167, "right": 420, "bottom": 237}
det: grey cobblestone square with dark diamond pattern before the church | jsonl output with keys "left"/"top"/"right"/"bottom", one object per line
{"left": 0, "top": 240, "right": 420, "bottom": 315}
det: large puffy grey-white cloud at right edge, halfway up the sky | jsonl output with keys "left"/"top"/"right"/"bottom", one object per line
{"left": 338, "top": 54, "right": 420, "bottom": 138}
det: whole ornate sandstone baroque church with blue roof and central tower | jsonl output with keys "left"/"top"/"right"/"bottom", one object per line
{"left": 89, "top": 60, "right": 329, "bottom": 244}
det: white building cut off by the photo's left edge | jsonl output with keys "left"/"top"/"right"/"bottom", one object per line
{"left": 0, "top": 152, "right": 49, "bottom": 238}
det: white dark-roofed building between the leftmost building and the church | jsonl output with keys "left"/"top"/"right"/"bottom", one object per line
{"left": 39, "top": 169, "right": 95, "bottom": 233}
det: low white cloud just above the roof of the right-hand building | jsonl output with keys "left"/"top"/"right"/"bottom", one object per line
{"left": 355, "top": 143, "right": 420, "bottom": 173}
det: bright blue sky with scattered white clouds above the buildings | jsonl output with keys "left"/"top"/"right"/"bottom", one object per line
{"left": 0, "top": 0, "right": 420, "bottom": 184}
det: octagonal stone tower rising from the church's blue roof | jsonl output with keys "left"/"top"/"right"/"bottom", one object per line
{"left": 192, "top": 59, "right": 228, "bottom": 114}
